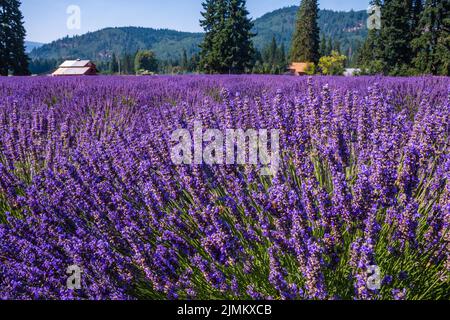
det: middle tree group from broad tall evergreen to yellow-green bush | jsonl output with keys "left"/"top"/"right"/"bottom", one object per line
{"left": 195, "top": 0, "right": 354, "bottom": 74}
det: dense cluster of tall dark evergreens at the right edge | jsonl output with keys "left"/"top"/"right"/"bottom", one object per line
{"left": 358, "top": 0, "right": 450, "bottom": 76}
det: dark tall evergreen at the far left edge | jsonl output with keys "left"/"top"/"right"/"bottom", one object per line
{"left": 0, "top": 0, "right": 30, "bottom": 75}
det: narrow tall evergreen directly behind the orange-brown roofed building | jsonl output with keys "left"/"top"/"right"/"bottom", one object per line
{"left": 291, "top": 0, "right": 320, "bottom": 63}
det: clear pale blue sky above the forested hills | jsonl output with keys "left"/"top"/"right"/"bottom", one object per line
{"left": 22, "top": 0, "right": 369, "bottom": 42}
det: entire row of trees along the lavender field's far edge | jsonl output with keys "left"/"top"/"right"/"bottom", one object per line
{"left": 4, "top": 0, "right": 450, "bottom": 75}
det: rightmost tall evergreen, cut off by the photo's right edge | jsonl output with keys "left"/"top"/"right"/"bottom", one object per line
{"left": 413, "top": 0, "right": 450, "bottom": 76}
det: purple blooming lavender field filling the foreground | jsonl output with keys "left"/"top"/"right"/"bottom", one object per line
{"left": 0, "top": 76, "right": 450, "bottom": 300}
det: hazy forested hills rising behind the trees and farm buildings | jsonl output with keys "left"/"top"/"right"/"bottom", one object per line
{"left": 30, "top": 6, "right": 367, "bottom": 61}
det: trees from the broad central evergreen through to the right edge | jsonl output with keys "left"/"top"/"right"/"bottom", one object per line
{"left": 200, "top": 0, "right": 450, "bottom": 76}
